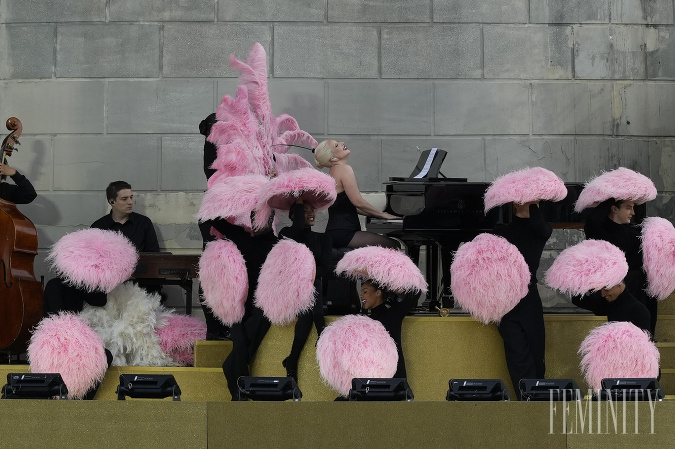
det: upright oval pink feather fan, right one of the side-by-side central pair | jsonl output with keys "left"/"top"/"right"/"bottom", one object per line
{"left": 255, "top": 239, "right": 316, "bottom": 326}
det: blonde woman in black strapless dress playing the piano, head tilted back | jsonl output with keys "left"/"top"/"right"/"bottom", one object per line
{"left": 314, "top": 140, "right": 400, "bottom": 249}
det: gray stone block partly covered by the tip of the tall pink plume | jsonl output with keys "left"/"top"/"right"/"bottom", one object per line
{"left": 162, "top": 23, "right": 272, "bottom": 78}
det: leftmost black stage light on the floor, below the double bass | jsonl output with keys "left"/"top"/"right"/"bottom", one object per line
{"left": 2, "top": 373, "right": 68, "bottom": 399}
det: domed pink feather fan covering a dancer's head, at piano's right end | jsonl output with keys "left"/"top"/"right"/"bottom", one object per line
{"left": 485, "top": 167, "right": 567, "bottom": 213}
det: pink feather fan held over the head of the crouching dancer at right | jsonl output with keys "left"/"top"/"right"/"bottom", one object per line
{"left": 546, "top": 239, "right": 628, "bottom": 296}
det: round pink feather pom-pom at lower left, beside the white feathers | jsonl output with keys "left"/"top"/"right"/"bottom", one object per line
{"left": 28, "top": 312, "right": 108, "bottom": 399}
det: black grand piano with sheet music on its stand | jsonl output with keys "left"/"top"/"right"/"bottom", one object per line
{"left": 366, "top": 148, "right": 596, "bottom": 311}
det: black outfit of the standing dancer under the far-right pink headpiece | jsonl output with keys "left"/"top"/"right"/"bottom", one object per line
{"left": 584, "top": 199, "right": 657, "bottom": 336}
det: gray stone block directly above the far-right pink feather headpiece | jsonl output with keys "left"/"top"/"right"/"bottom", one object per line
{"left": 575, "top": 137, "right": 649, "bottom": 182}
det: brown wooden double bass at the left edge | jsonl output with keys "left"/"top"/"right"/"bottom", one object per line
{"left": 0, "top": 117, "right": 42, "bottom": 355}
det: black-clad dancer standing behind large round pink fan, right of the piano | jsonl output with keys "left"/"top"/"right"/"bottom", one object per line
{"left": 494, "top": 204, "right": 553, "bottom": 400}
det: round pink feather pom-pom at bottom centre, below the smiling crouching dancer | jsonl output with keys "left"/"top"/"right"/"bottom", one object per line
{"left": 316, "top": 315, "right": 398, "bottom": 396}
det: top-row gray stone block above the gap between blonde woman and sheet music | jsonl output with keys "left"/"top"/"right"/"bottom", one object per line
{"left": 328, "top": 0, "right": 431, "bottom": 22}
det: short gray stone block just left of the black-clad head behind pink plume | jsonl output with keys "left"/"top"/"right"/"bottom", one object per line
{"left": 161, "top": 136, "right": 206, "bottom": 191}
